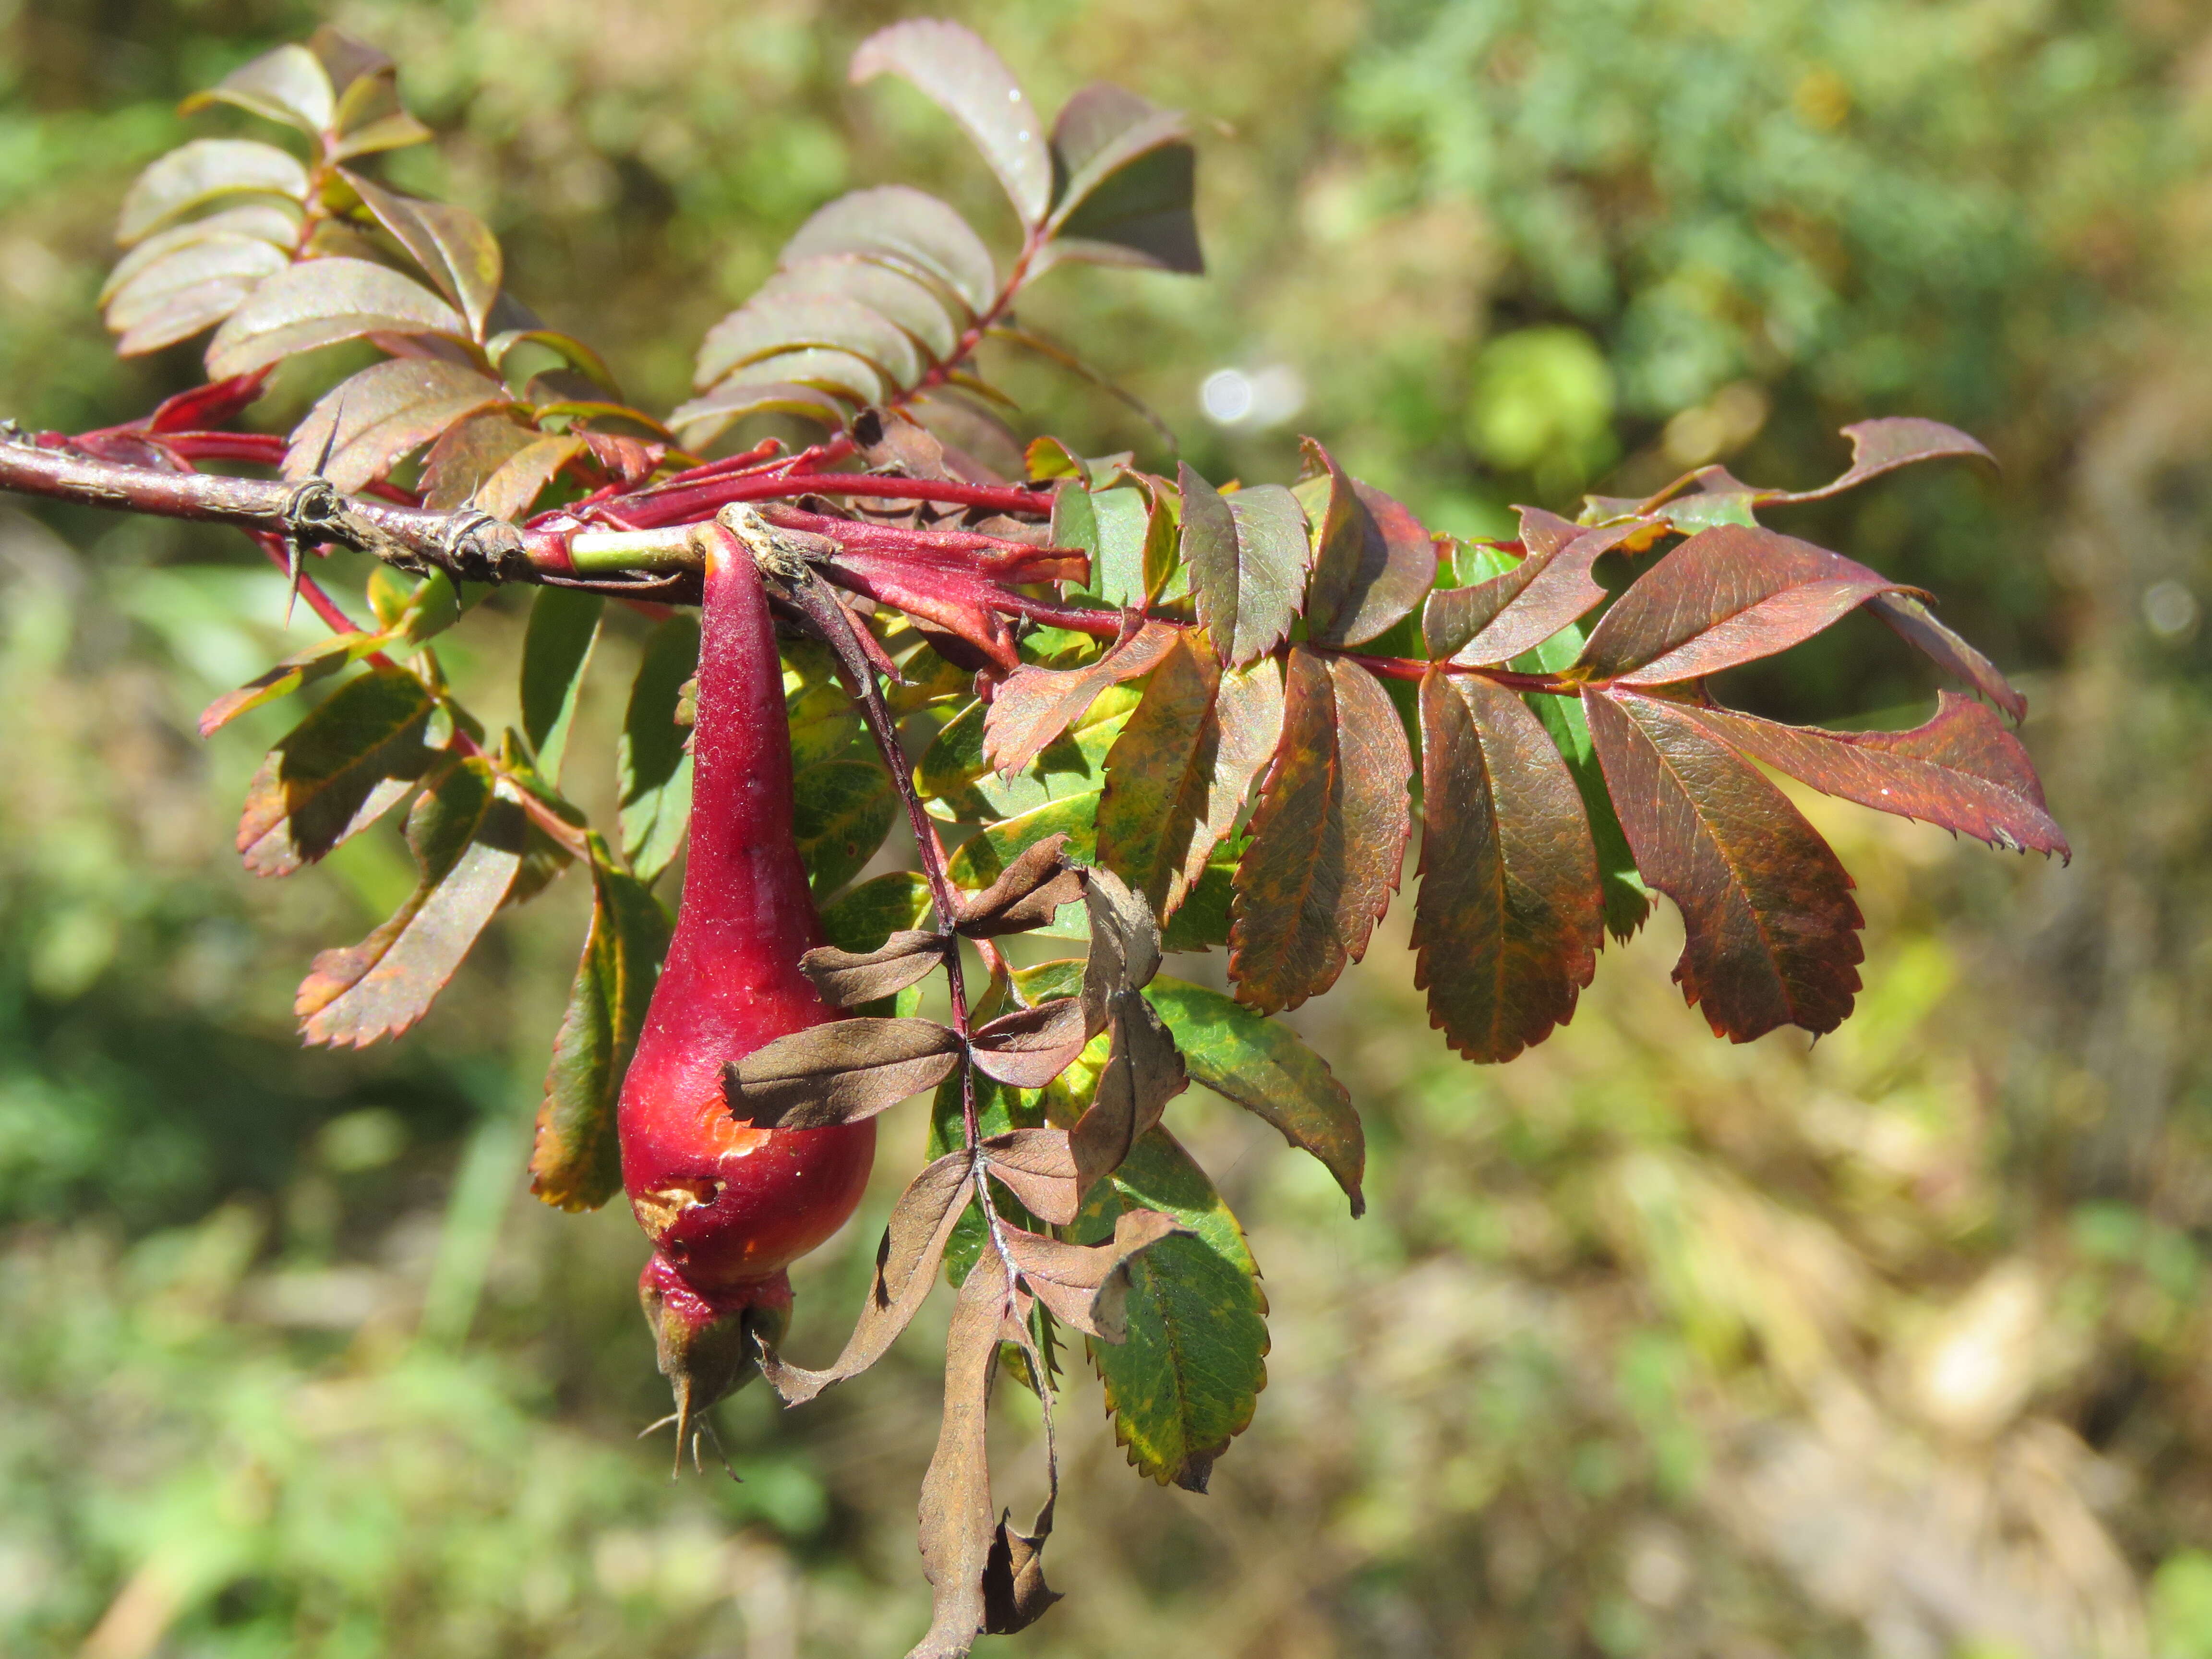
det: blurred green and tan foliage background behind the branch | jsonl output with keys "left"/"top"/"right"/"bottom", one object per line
{"left": 0, "top": 0, "right": 2212, "bottom": 1659}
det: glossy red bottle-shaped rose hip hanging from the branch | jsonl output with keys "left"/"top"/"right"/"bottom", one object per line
{"left": 617, "top": 529, "right": 876, "bottom": 1307}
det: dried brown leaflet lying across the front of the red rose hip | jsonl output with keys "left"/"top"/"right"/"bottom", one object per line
{"left": 723, "top": 1018, "right": 960, "bottom": 1128}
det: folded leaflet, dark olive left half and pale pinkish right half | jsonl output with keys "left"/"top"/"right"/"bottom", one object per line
{"left": 1097, "top": 633, "right": 1283, "bottom": 918}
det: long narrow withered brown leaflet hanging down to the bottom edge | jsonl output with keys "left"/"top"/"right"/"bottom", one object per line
{"left": 907, "top": 1250, "right": 1013, "bottom": 1659}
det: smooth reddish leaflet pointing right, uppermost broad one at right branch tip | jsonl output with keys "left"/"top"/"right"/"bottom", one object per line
{"left": 1582, "top": 524, "right": 1898, "bottom": 685}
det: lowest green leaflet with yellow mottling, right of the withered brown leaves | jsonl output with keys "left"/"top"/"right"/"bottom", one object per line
{"left": 1075, "top": 1128, "right": 1267, "bottom": 1491}
